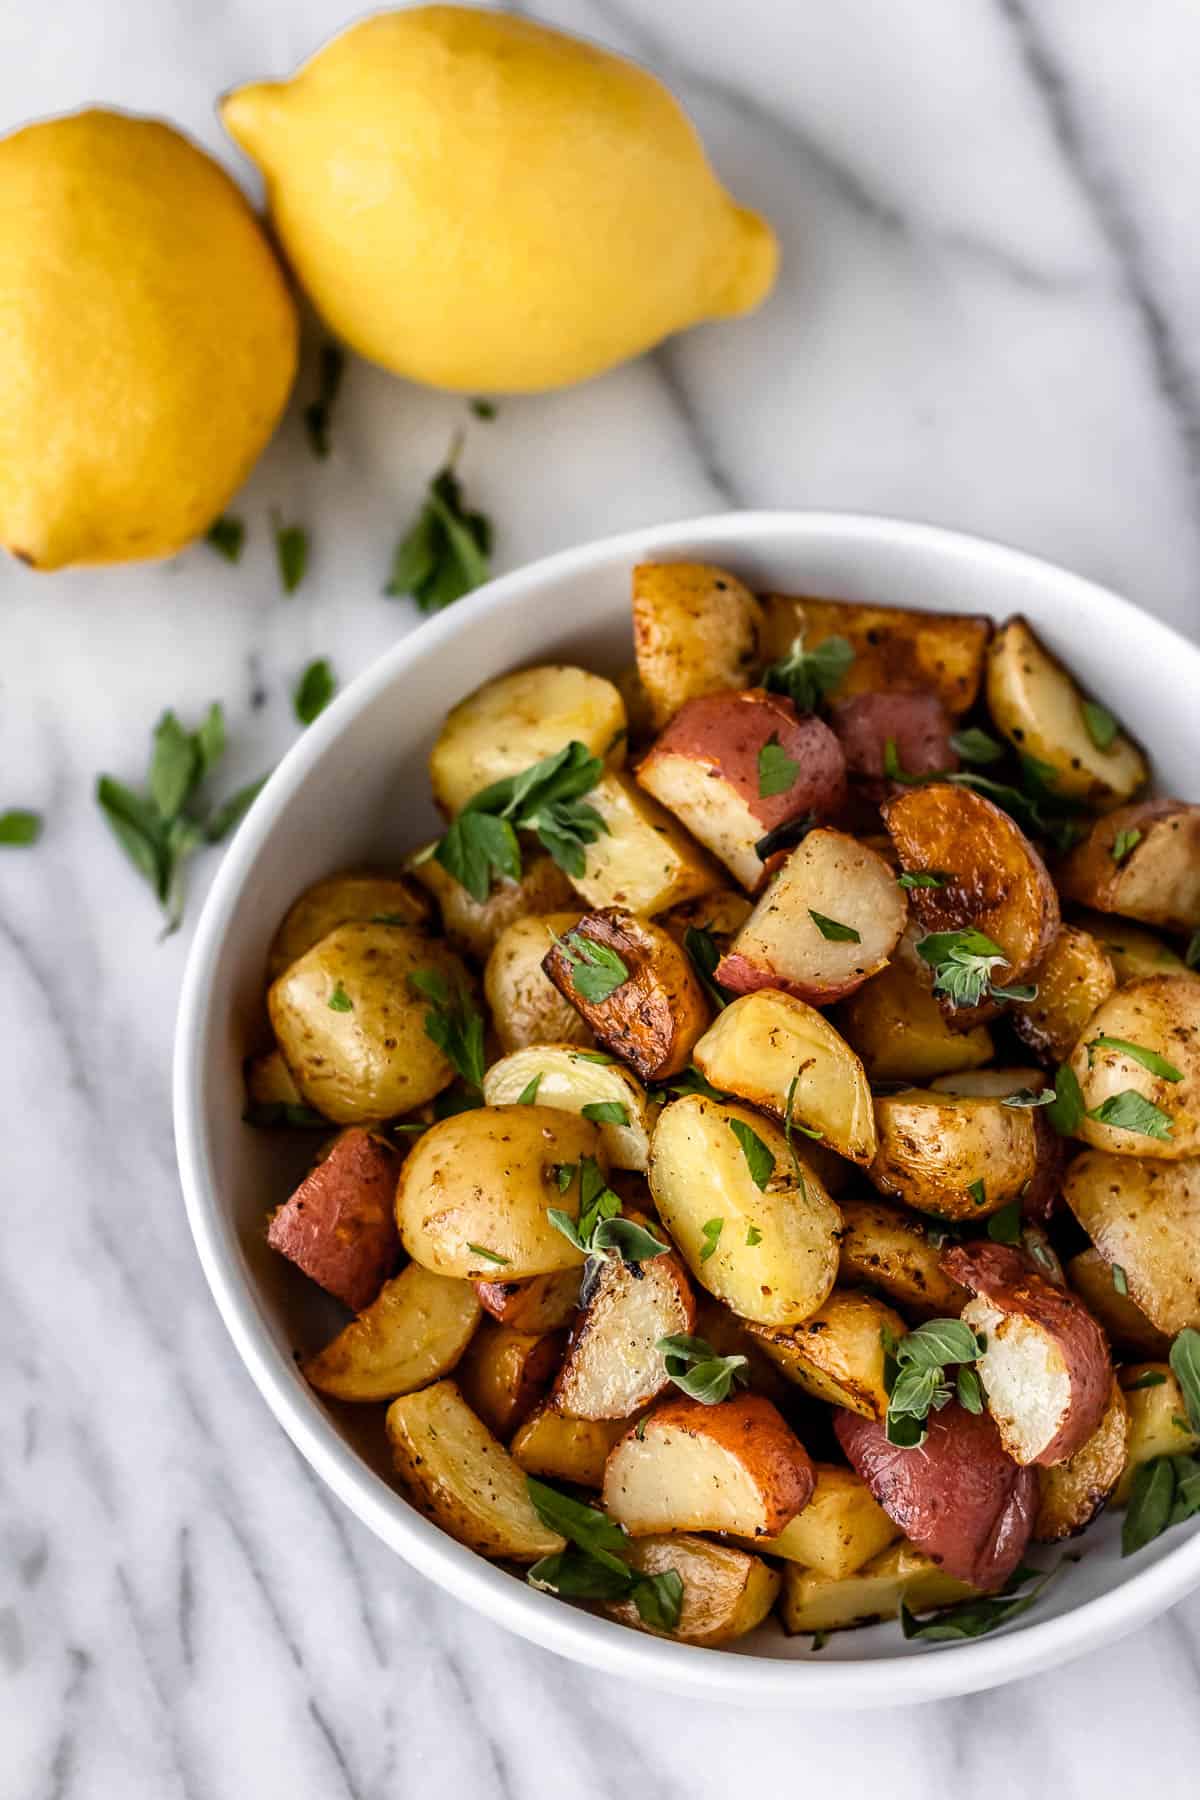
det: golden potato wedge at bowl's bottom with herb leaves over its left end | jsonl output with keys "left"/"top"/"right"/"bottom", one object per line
{"left": 604, "top": 1532, "right": 781, "bottom": 1649}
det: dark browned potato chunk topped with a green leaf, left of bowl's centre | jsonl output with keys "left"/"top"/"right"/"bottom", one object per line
{"left": 542, "top": 907, "right": 709, "bottom": 1082}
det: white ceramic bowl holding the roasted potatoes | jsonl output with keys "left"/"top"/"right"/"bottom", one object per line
{"left": 175, "top": 513, "right": 1200, "bottom": 1708}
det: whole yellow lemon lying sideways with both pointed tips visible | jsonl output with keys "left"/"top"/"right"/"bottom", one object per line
{"left": 221, "top": 5, "right": 777, "bottom": 392}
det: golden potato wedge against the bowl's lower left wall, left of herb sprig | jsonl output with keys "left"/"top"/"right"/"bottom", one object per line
{"left": 387, "top": 1381, "right": 565, "bottom": 1562}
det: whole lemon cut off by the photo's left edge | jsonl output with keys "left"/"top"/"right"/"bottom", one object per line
{"left": 0, "top": 110, "right": 299, "bottom": 569}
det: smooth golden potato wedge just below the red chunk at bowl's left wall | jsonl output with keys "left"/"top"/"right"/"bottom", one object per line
{"left": 302, "top": 1262, "right": 482, "bottom": 1400}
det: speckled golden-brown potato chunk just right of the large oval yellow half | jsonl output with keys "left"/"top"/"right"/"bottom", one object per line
{"left": 867, "top": 1087, "right": 1038, "bottom": 1219}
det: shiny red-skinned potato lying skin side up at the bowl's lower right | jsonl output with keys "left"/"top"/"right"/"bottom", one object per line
{"left": 833, "top": 1400, "right": 1038, "bottom": 1589}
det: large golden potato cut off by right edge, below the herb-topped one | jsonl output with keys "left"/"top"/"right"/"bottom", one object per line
{"left": 1063, "top": 1150, "right": 1200, "bottom": 1337}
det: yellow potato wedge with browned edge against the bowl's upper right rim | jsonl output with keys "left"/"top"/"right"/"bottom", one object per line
{"left": 988, "top": 617, "right": 1150, "bottom": 808}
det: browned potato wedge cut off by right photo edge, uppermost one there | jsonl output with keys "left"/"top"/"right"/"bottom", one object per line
{"left": 1056, "top": 799, "right": 1200, "bottom": 931}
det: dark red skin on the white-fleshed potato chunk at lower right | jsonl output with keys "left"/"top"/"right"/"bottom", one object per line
{"left": 939, "top": 1244, "right": 1112, "bottom": 1469}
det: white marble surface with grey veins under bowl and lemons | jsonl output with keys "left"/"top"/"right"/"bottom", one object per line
{"left": 0, "top": 0, "right": 1200, "bottom": 1800}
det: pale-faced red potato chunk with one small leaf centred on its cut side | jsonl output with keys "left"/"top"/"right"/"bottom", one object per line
{"left": 716, "top": 830, "right": 909, "bottom": 1006}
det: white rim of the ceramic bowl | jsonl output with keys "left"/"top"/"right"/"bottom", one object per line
{"left": 173, "top": 509, "right": 1200, "bottom": 1708}
